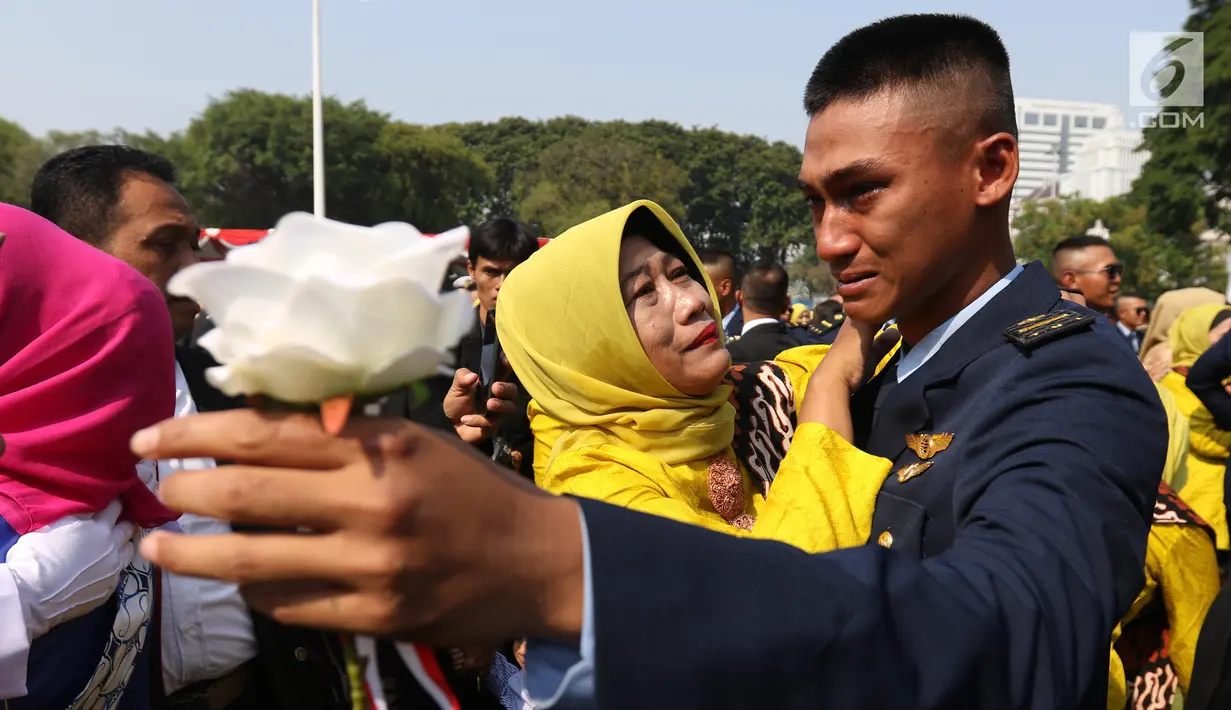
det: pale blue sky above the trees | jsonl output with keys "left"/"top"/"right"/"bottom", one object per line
{"left": 0, "top": 0, "right": 1188, "bottom": 145}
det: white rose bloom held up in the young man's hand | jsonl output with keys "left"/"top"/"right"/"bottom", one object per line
{"left": 167, "top": 213, "right": 473, "bottom": 404}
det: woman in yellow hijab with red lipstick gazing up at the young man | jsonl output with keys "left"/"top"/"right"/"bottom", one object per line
{"left": 496, "top": 201, "right": 890, "bottom": 552}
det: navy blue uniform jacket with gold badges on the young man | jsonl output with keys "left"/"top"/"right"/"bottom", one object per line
{"left": 581, "top": 263, "right": 1167, "bottom": 710}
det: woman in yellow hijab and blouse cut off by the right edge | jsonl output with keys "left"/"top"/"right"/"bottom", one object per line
{"left": 1161, "top": 301, "right": 1231, "bottom": 551}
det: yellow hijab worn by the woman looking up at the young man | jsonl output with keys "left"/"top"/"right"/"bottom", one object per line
{"left": 496, "top": 199, "right": 735, "bottom": 465}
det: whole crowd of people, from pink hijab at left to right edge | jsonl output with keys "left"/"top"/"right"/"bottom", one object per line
{"left": 0, "top": 9, "right": 1231, "bottom": 710}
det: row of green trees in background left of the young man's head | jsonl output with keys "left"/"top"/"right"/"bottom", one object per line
{"left": 7, "top": 90, "right": 824, "bottom": 263}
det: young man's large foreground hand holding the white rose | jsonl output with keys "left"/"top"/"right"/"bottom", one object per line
{"left": 133, "top": 410, "right": 583, "bottom": 647}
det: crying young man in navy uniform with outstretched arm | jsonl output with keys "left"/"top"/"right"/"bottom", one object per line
{"left": 134, "top": 15, "right": 1167, "bottom": 710}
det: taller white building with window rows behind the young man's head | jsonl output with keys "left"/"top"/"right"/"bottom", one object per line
{"left": 1013, "top": 98, "right": 1124, "bottom": 202}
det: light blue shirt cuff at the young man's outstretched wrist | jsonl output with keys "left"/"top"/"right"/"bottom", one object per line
{"left": 526, "top": 506, "right": 597, "bottom": 710}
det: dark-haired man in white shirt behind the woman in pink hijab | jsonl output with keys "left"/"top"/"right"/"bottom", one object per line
{"left": 31, "top": 145, "right": 260, "bottom": 710}
